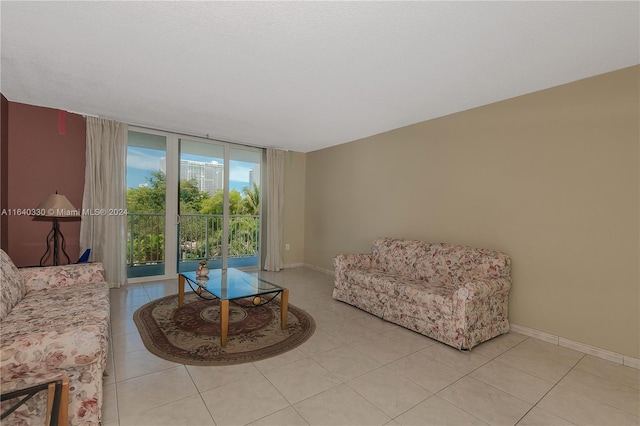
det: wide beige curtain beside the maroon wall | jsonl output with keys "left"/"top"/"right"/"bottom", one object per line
{"left": 80, "top": 117, "right": 128, "bottom": 287}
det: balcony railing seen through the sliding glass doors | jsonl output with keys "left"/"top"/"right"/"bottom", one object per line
{"left": 127, "top": 213, "right": 260, "bottom": 270}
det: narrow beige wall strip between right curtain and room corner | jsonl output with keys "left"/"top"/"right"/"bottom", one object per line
{"left": 282, "top": 151, "right": 306, "bottom": 266}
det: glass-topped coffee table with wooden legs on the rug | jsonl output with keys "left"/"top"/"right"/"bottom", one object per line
{"left": 178, "top": 268, "right": 289, "bottom": 346}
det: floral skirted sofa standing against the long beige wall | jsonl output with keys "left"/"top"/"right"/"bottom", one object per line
{"left": 333, "top": 238, "right": 511, "bottom": 349}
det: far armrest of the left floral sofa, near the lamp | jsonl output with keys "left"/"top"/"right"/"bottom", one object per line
{"left": 20, "top": 262, "right": 104, "bottom": 292}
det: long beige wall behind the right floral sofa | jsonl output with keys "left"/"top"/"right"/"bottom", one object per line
{"left": 304, "top": 66, "right": 640, "bottom": 358}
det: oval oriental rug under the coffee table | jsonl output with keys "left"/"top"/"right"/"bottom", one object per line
{"left": 133, "top": 293, "right": 315, "bottom": 365}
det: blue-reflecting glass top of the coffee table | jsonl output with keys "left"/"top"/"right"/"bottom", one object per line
{"left": 180, "top": 268, "right": 284, "bottom": 300}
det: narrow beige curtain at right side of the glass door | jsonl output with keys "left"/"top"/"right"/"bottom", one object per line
{"left": 264, "top": 148, "right": 284, "bottom": 271}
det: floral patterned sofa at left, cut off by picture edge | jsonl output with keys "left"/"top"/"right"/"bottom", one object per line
{"left": 0, "top": 250, "right": 109, "bottom": 425}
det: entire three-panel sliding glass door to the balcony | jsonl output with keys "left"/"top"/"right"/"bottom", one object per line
{"left": 127, "top": 129, "right": 262, "bottom": 278}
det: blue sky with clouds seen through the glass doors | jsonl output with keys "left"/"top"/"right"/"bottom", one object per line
{"left": 127, "top": 146, "right": 260, "bottom": 193}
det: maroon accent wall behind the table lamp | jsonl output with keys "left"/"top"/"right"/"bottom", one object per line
{"left": 3, "top": 101, "right": 86, "bottom": 266}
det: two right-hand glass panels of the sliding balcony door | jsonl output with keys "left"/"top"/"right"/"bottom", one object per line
{"left": 177, "top": 138, "right": 261, "bottom": 272}
